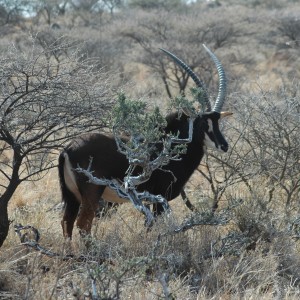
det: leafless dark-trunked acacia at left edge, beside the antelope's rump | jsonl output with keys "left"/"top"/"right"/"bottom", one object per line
{"left": 0, "top": 39, "right": 112, "bottom": 246}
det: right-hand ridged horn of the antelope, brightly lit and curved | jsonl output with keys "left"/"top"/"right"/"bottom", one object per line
{"left": 203, "top": 44, "right": 227, "bottom": 113}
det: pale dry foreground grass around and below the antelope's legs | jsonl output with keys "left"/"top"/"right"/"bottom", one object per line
{"left": 0, "top": 171, "right": 300, "bottom": 299}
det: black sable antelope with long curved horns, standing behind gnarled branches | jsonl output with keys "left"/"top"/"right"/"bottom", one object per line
{"left": 59, "top": 45, "right": 231, "bottom": 238}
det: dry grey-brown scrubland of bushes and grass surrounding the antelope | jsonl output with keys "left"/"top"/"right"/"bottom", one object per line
{"left": 0, "top": 0, "right": 300, "bottom": 299}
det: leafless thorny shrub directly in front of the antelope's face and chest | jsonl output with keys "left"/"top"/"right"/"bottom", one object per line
{"left": 193, "top": 82, "right": 300, "bottom": 211}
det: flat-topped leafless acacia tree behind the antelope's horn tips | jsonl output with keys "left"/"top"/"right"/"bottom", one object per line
{"left": 119, "top": 10, "right": 240, "bottom": 98}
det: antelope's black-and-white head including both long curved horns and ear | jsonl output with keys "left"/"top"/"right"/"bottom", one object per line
{"left": 161, "top": 45, "right": 232, "bottom": 152}
